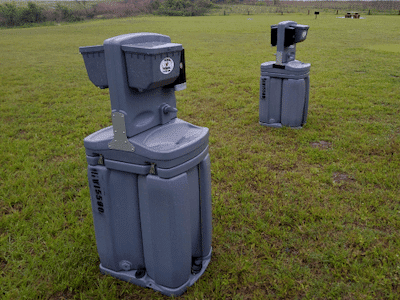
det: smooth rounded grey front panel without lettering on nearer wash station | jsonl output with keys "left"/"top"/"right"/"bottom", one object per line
{"left": 139, "top": 173, "right": 195, "bottom": 288}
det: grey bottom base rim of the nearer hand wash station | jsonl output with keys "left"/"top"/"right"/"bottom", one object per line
{"left": 100, "top": 248, "right": 212, "bottom": 296}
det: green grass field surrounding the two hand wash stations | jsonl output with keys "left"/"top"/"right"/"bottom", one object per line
{"left": 0, "top": 14, "right": 400, "bottom": 299}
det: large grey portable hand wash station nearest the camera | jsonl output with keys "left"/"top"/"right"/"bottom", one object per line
{"left": 79, "top": 33, "right": 212, "bottom": 296}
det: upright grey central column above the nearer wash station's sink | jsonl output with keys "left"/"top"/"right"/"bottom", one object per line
{"left": 104, "top": 33, "right": 179, "bottom": 138}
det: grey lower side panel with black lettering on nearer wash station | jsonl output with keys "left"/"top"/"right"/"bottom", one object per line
{"left": 88, "top": 166, "right": 144, "bottom": 271}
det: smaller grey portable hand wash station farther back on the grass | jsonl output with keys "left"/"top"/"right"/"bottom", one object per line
{"left": 259, "top": 21, "right": 311, "bottom": 128}
